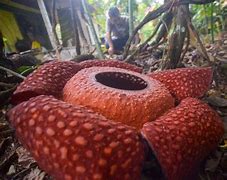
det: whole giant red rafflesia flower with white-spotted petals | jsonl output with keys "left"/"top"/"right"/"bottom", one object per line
{"left": 8, "top": 60, "right": 224, "bottom": 180}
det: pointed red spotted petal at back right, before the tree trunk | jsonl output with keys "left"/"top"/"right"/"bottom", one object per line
{"left": 148, "top": 67, "right": 213, "bottom": 101}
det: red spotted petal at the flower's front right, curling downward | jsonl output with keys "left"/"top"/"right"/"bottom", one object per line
{"left": 142, "top": 98, "right": 224, "bottom": 180}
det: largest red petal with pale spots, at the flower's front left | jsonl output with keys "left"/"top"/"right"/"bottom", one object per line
{"left": 8, "top": 95, "right": 144, "bottom": 180}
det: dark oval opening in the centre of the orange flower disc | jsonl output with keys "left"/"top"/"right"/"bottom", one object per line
{"left": 95, "top": 72, "right": 147, "bottom": 90}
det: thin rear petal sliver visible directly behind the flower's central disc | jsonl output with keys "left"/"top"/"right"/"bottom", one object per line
{"left": 80, "top": 59, "right": 143, "bottom": 73}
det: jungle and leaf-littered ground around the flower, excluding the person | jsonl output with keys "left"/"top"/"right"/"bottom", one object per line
{"left": 0, "top": 0, "right": 227, "bottom": 180}
